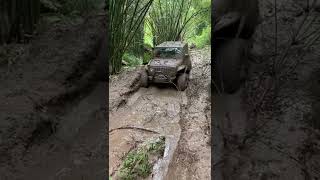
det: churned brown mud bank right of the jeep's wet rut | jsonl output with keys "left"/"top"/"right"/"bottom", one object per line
{"left": 165, "top": 47, "right": 211, "bottom": 180}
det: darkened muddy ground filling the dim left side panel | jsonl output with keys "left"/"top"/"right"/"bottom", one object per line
{"left": 0, "top": 17, "right": 107, "bottom": 180}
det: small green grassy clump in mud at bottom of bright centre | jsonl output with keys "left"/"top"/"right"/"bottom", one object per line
{"left": 119, "top": 137, "right": 165, "bottom": 180}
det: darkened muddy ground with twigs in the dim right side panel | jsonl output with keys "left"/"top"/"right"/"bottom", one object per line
{"left": 212, "top": 0, "right": 320, "bottom": 180}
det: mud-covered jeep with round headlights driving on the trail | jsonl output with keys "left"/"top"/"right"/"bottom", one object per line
{"left": 140, "top": 41, "right": 192, "bottom": 91}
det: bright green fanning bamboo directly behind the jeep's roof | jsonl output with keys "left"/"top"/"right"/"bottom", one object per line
{"left": 147, "top": 0, "right": 210, "bottom": 44}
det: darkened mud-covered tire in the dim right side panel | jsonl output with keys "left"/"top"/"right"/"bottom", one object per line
{"left": 214, "top": 39, "right": 247, "bottom": 94}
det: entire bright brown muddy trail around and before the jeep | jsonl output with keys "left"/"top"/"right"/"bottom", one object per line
{"left": 109, "top": 47, "right": 211, "bottom": 179}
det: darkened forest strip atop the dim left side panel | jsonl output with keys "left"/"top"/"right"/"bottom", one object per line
{"left": 0, "top": 0, "right": 104, "bottom": 44}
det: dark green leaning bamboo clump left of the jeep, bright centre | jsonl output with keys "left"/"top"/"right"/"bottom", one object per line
{"left": 108, "top": 0, "right": 153, "bottom": 74}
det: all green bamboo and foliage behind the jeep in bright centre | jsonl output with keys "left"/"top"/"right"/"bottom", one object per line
{"left": 109, "top": 0, "right": 211, "bottom": 74}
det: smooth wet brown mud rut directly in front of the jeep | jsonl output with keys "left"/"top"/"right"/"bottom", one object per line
{"left": 109, "top": 81, "right": 186, "bottom": 179}
